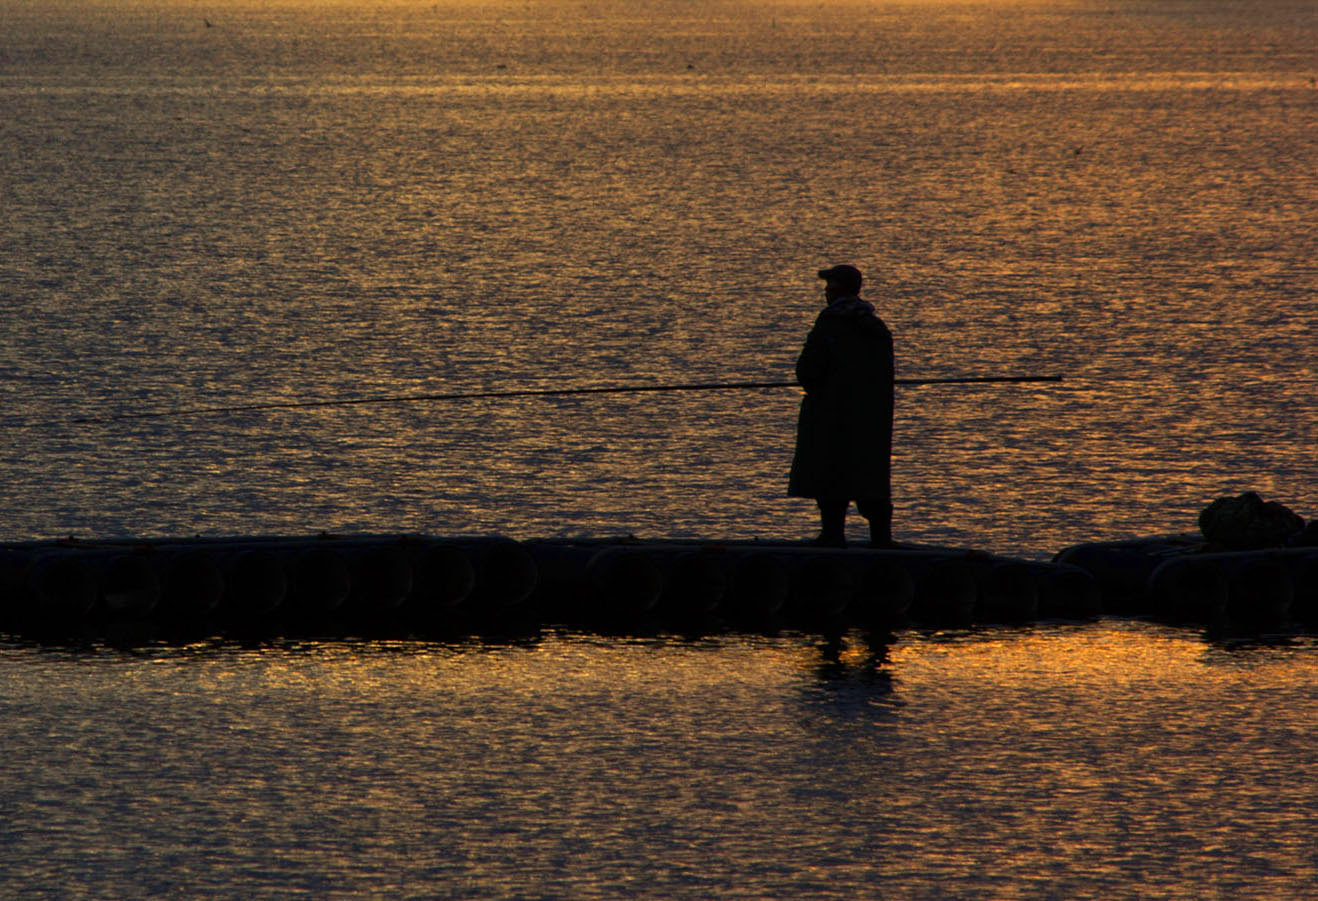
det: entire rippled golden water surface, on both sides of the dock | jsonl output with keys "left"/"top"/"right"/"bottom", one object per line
{"left": 0, "top": 0, "right": 1318, "bottom": 898}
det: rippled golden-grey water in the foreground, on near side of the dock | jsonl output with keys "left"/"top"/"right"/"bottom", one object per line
{"left": 0, "top": 620, "right": 1318, "bottom": 898}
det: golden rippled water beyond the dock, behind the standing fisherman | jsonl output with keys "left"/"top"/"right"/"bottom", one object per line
{"left": 0, "top": 3, "right": 1318, "bottom": 555}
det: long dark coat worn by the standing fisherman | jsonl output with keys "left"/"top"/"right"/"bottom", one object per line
{"left": 787, "top": 298, "right": 894, "bottom": 502}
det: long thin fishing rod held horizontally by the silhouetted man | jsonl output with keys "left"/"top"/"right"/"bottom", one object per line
{"left": 67, "top": 375, "right": 1062, "bottom": 424}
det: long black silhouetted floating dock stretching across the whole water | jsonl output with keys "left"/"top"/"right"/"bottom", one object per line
{"left": 0, "top": 533, "right": 1318, "bottom": 638}
